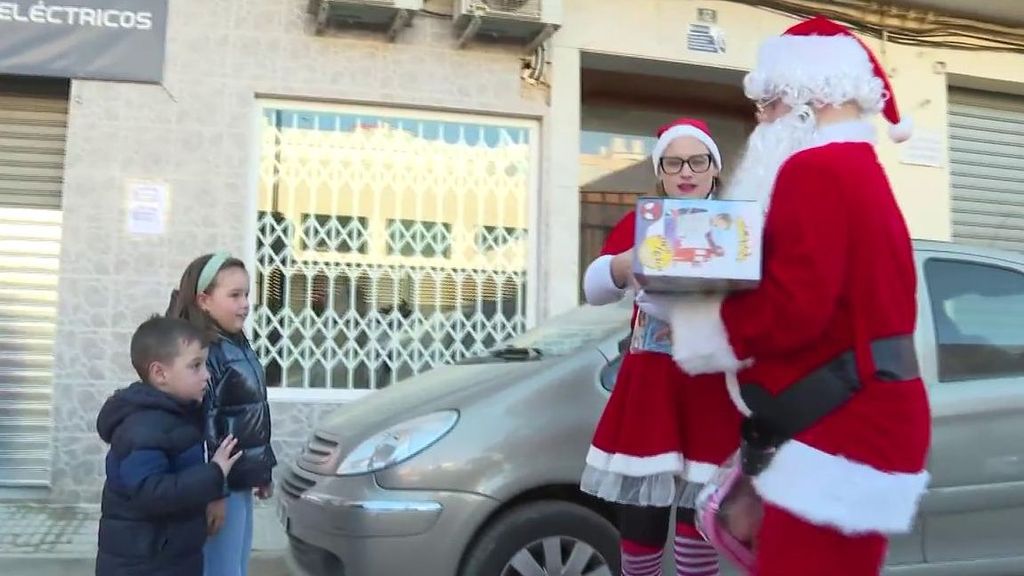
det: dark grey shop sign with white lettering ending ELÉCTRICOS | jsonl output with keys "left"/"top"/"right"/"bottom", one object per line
{"left": 0, "top": 0, "right": 168, "bottom": 82}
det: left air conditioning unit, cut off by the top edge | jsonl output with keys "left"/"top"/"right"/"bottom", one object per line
{"left": 309, "top": 0, "right": 423, "bottom": 40}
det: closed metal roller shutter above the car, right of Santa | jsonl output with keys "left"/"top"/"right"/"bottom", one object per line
{"left": 949, "top": 89, "right": 1024, "bottom": 251}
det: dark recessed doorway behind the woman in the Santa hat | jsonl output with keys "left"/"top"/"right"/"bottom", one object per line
{"left": 580, "top": 54, "right": 755, "bottom": 300}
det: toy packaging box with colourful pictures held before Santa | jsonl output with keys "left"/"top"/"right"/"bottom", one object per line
{"left": 633, "top": 198, "right": 764, "bottom": 292}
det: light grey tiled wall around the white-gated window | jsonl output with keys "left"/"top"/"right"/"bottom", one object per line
{"left": 52, "top": 0, "right": 548, "bottom": 502}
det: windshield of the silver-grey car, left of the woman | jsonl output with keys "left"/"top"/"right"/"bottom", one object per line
{"left": 496, "top": 299, "right": 633, "bottom": 357}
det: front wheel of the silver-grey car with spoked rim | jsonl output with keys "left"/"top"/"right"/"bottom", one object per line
{"left": 461, "top": 501, "right": 620, "bottom": 576}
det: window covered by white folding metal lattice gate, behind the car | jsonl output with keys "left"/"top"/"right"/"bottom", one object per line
{"left": 254, "top": 102, "right": 538, "bottom": 388}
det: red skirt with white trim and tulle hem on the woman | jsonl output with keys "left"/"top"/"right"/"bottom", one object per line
{"left": 581, "top": 353, "right": 741, "bottom": 506}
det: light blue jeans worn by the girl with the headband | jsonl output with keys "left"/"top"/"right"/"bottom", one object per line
{"left": 203, "top": 490, "right": 253, "bottom": 576}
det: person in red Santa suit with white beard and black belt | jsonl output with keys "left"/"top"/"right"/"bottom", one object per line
{"left": 670, "top": 17, "right": 931, "bottom": 576}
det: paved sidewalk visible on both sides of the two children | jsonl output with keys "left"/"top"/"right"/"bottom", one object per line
{"left": 0, "top": 502, "right": 288, "bottom": 576}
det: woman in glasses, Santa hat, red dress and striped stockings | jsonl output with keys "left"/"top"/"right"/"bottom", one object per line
{"left": 581, "top": 119, "right": 740, "bottom": 576}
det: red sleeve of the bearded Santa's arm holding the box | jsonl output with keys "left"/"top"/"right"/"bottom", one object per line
{"left": 721, "top": 153, "right": 852, "bottom": 359}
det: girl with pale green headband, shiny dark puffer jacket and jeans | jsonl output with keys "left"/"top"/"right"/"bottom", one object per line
{"left": 167, "top": 252, "right": 278, "bottom": 576}
